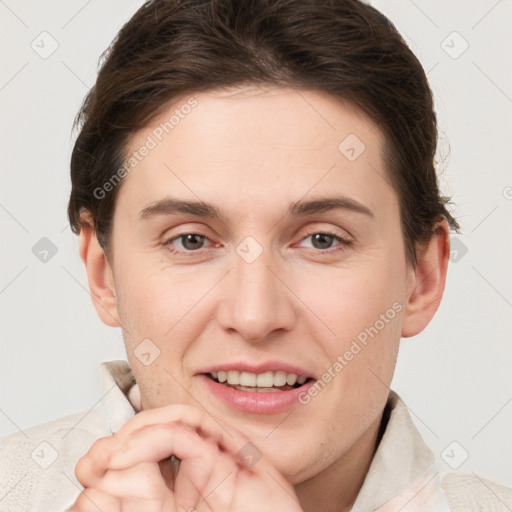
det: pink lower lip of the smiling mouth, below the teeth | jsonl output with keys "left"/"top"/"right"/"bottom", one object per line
{"left": 200, "top": 375, "right": 315, "bottom": 414}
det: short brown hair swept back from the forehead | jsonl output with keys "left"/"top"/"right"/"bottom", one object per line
{"left": 68, "top": 0, "right": 459, "bottom": 264}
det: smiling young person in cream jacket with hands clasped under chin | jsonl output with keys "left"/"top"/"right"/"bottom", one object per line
{"left": 2, "top": 0, "right": 512, "bottom": 512}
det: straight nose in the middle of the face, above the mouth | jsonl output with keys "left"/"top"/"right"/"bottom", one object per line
{"left": 218, "top": 240, "right": 296, "bottom": 342}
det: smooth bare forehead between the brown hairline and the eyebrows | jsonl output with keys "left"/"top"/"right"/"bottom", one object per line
{"left": 120, "top": 87, "right": 389, "bottom": 223}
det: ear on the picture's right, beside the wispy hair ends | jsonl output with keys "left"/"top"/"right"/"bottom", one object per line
{"left": 402, "top": 219, "right": 450, "bottom": 338}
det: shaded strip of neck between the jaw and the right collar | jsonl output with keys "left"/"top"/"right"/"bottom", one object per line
{"left": 295, "top": 416, "right": 381, "bottom": 512}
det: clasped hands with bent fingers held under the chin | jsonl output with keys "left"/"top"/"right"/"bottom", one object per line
{"left": 71, "top": 405, "right": 302, "bottom": 512}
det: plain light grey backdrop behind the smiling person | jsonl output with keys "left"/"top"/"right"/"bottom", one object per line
{"left": 0, "top": 0, "right": 512, "bottom": 487}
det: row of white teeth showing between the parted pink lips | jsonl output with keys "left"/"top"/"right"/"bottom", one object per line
{"left": 204, "top": 370, "right": 313, "bottom": 393}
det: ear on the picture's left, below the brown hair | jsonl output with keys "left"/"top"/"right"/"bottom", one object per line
{"left": 80, "top": 217, "right": 121, "bottom": 327}
